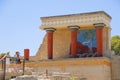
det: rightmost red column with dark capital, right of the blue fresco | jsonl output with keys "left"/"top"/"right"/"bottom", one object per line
{"left": 93, "top": 23, "right": 105, "bottom": 56}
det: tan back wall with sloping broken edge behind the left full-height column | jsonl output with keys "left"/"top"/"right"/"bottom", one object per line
{"left": 36, "top": 29, "right": 71, "bottom": 60}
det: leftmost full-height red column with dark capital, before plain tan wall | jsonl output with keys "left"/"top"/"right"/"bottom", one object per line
{"left": 45, "top": 28, "right": 55, "bottom": 59}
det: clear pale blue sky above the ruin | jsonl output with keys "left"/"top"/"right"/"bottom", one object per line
{"left": 0, "top": 0, "right": 120, "bottom": 55}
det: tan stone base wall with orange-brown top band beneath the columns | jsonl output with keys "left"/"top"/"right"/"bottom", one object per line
{"left": 26, "top": 57, "right": 111, "bottom": 80}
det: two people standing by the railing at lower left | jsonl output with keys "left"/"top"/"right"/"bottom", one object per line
{"left": 0, "top": 51, "right": 22, "bottom": 72}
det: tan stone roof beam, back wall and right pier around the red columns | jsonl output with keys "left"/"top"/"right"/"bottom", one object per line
{"left": 35, "top": 11, "right": 111, "bottom": 60}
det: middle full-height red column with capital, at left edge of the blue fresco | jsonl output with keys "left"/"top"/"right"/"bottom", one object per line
{"left": 69, "top": 26, "right": 79, "bottom": 57}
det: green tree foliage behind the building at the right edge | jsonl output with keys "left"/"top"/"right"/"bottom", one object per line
{"left": 111, "top": 36, "right": 120, "bottom": 55}
